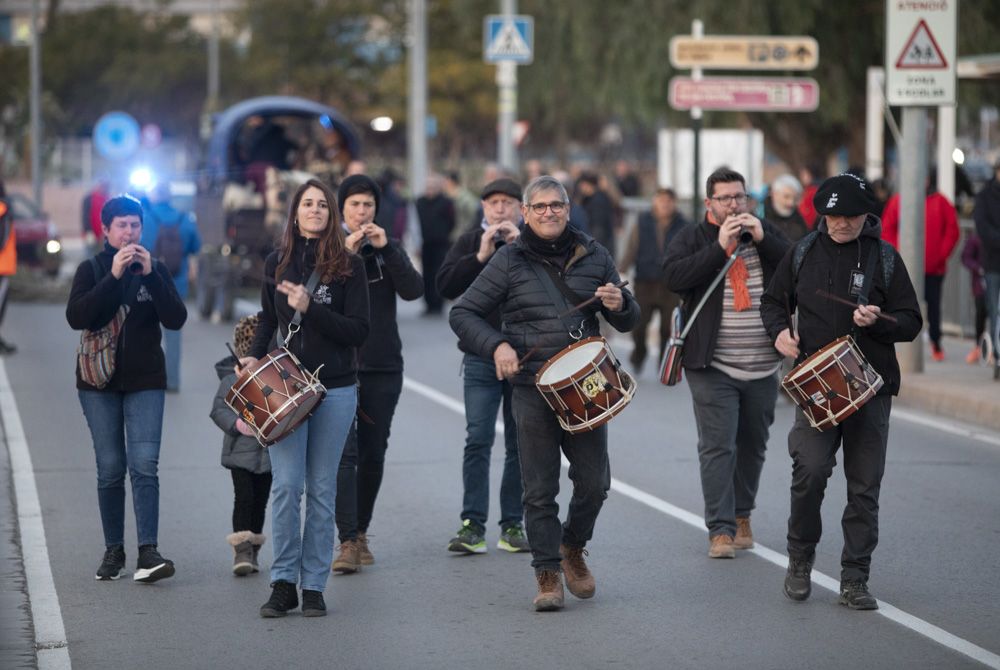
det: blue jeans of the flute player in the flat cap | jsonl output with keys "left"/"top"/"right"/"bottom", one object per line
{"left": 462, "top": 354, "right": 524, "bottom": 531}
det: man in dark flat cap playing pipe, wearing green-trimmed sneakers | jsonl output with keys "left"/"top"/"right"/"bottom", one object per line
{"left": 437, "top": 178, "right": 528, "bottom": 554}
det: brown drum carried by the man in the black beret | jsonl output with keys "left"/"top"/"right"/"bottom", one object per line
{"left": 781, "top": 335, "right": 882, "bottom": 430}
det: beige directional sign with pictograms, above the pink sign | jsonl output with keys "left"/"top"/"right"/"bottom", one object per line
{"left": 670, "top": 35, "right": 819, "bottom": 70}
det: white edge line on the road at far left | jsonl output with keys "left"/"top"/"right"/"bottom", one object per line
{"left": 0, "top": 359, "right": 72, "bottom": 670}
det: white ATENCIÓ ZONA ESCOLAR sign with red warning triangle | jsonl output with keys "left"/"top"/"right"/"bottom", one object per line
{"left": 885, "top": 0, "right": 958, "bottom": 107}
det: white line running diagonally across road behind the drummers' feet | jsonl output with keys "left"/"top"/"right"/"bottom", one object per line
{"left": 403, "top": 376, "right": 1000, "bottom": 670}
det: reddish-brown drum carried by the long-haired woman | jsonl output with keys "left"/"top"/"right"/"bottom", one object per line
{"left": 226, "top": 348, "right": 326, "bottom": 447}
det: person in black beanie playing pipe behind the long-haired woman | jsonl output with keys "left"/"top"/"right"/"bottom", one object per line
{"left": 332, "top": 174, "right": 424, "bottom": 574}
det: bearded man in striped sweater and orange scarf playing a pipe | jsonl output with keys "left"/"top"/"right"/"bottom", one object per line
{"left": 663, "top": 168, "right": 789, "bottom": 558}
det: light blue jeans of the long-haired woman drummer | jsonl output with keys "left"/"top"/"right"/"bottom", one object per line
{"left": 268, "top": 386, "right": 358, "bottom": 591}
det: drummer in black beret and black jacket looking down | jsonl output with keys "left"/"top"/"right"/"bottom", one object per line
{"left": 760, "top": 174, "right": 922, "bottom": 610}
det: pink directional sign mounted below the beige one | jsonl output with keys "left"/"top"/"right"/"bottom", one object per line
{"left": 670, "top": 77, "right": 819, "bottom": 112}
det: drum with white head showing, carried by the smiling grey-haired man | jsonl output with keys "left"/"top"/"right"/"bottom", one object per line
{"left": 535, "top": 337, "right": 635, "bottom": 433}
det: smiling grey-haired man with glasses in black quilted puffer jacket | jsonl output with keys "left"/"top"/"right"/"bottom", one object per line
{"left": 450, "top": 175, "right": 639, "bottom": 611}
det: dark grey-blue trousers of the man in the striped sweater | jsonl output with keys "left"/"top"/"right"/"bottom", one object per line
{"left": 684, "top": 368, "right": 778, "bottom": 537}
